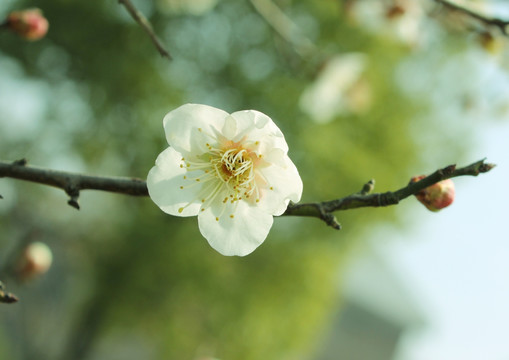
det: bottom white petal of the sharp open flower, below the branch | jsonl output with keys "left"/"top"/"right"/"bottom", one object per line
{"left": 198, "top": 201, "right": 274, "bottom": 256}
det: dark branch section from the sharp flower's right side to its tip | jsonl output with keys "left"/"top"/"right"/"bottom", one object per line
{"left": 283, "top": 160, "right": 495, "bottom": 229}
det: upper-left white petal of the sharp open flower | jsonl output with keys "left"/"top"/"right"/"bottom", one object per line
{"left": 163, "top": 104, "right": 229, "bottom": 157}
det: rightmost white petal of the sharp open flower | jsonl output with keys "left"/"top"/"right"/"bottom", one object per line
{"left": 258, "top": 151, "right": 303, "bottom": 216}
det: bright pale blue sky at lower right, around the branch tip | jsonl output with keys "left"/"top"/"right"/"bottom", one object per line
{"left": 385, "top": 122, "right": 509, "bottom": 360}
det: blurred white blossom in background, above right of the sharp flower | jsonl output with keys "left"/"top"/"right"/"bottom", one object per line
{"left": 299, "top": 53, "right": 372, "bottom": 123}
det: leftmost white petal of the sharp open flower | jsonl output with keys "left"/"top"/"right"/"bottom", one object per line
{"left": 147, "top": 147, "right": 203, "bottom": 216}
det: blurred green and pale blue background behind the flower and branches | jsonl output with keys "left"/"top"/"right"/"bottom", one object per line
{"left": 0, "top": 0, "right": 509, "bottom": 360}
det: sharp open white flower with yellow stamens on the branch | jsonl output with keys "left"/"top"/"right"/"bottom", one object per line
{"left": 147, "top": 104, "right": 302, "bottom": 256}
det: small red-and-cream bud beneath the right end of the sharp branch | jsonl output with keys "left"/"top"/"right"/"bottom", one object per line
{"left": 410, "top": 175, "right": 455, "bottom": 211}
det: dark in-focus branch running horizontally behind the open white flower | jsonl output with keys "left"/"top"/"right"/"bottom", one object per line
{"left": 0, "top": 159, "right": 495, "bottom": 226}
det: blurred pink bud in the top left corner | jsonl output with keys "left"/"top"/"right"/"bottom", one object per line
{"left": 6, "top": 9, "right": 49, "bottom": 40}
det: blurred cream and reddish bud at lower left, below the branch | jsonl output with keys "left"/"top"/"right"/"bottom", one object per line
{"left": 15, "top": 241, "right": 53, "bottom": 280}
